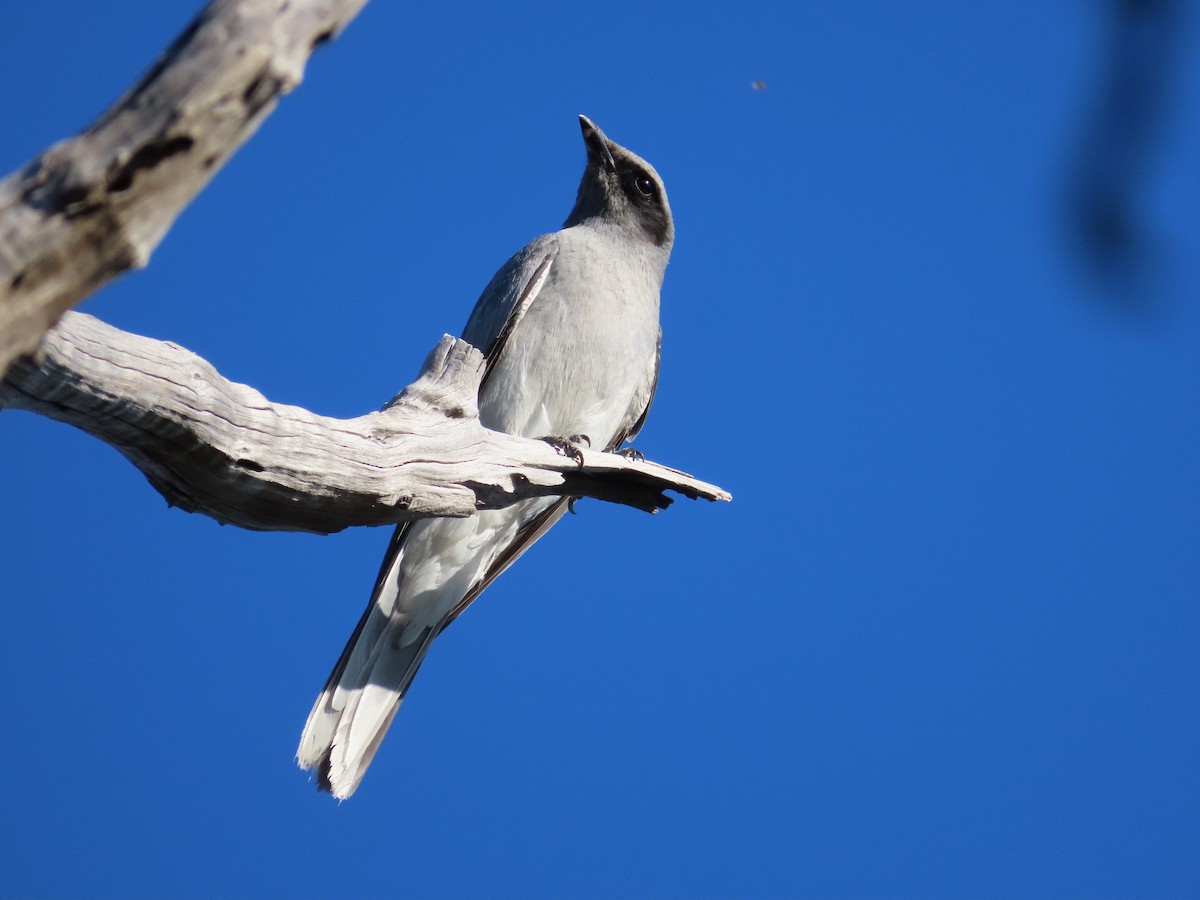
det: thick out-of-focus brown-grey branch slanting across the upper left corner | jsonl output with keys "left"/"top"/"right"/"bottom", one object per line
{"left": 0, "top": 0, "right": 366, "bottom": 374}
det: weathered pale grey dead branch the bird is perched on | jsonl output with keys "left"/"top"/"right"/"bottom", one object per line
{"left": 0, "top": 312, "right": 730, "bottom": 533}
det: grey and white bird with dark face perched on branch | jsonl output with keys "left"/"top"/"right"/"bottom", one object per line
{"left": 296, "top": 115, "right": 674, "bottom": 800}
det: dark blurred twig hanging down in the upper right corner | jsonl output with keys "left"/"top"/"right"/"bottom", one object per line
{"left": 1067, "top": 0, "right": 1182, "bottom": 287}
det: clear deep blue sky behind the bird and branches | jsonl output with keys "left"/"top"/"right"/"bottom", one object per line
{"left": 0, "top": 0, "right": 1200, "bottom": 898}
